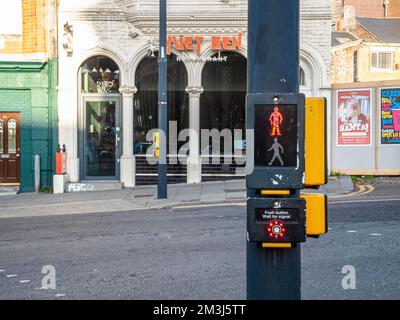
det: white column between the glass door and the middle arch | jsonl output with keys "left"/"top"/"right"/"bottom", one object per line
{"left": 119, "top": 86, "right": 137, "bottom": 188}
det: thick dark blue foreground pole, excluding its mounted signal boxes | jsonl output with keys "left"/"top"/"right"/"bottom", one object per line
{"left": 246, "top": 0, "right": 301, "bottom": 300}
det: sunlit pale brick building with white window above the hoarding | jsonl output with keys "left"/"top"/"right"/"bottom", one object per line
{"left": 331, "top": 18, "right": 400, "bottom": 84}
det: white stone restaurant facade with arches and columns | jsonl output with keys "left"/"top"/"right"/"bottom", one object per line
{"left": 58, "top": 0, "right": 331, "bottom": 187}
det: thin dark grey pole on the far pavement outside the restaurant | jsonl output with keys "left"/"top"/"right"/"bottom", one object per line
{"left": 157, "top": 0, "right": 168, "bottom": 199}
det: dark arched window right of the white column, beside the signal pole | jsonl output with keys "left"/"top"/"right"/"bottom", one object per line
{"left": 200, "top": 52, "right": 247, "bottom": 181}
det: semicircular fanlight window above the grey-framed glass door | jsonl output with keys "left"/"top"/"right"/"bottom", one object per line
{"left": 81, "top": 56, "right": 120, "bottom": 94}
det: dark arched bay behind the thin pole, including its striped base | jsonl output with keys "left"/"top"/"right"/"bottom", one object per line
{"left": 133, "top": 52, "right": 189, "bottom": 185}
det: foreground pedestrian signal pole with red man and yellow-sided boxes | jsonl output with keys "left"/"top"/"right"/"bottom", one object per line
{"left": 246, "top": 0, "right": 327, "bottom": 300}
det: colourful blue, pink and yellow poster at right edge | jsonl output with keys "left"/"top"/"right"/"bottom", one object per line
{"left": 381, "top": 88, "right": 400, "bottom": 144}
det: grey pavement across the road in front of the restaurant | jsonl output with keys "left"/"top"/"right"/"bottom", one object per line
{"left": 0, "top": 176, "right": 354, "bottom": 218}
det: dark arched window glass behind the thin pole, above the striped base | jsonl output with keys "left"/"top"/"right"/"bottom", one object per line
{"left": 134, "top": 52, "right": 189, "bottom": 154}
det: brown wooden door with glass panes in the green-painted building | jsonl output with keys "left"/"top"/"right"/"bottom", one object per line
{"left": 0, "top": 112, "right": 21, "bottom": 185}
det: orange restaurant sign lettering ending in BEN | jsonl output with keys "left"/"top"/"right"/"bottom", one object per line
{"left": 167, "top": 32, "right": 242, "bottom": 55}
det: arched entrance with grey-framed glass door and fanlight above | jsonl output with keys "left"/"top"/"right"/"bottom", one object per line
{"left": 78, "top": 56, "right": 121, "bottom": 180}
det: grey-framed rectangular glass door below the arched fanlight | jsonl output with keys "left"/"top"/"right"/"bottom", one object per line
{"left": 83, "top": 98, "right": 120, "bottom": 180}
